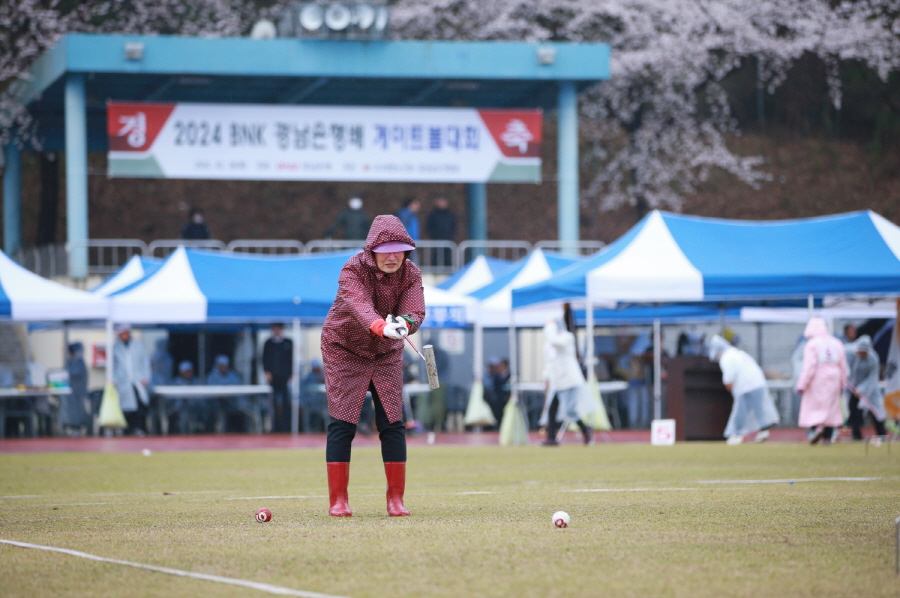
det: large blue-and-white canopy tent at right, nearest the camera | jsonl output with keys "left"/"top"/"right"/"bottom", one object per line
{"left": 513, "top": 211, "right": 900, "bottom": 422}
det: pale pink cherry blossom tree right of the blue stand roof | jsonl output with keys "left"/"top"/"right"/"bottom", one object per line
{"left": 392, "top": 0, "right": 900, "bottom": 210}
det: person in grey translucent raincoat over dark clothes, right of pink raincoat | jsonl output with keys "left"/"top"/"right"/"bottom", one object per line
{"left": 847, "top": 334, "right": 887, "bottom": 440}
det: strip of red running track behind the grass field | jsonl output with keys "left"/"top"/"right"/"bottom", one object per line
{"left": 0, "top": 428, "right": 824, "bottom": 454}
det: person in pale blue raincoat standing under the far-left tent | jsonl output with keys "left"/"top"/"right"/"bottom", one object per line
{"left": 112, "top": 324, "right": 150, "bottom": 434}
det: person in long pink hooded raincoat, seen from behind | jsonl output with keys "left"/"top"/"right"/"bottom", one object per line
{"left": 797, "top": 318, "right": 847, "bottom": 444}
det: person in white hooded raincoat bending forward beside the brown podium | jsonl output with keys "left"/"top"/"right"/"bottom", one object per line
{"left": 709, "top": 334, "right": 778, "bottom": 444}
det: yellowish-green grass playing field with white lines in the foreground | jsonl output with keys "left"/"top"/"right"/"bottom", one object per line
{"left": 0, "top": 442, "right": 900, "bottom": 598}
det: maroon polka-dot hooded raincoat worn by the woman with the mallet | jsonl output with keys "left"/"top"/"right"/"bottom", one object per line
{"left": 322, "top": 216, "right": 425, "bottom": 424}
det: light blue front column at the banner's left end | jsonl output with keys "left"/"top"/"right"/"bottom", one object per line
{"left": 66, "top": 73, "right": 88, "bottom": 279}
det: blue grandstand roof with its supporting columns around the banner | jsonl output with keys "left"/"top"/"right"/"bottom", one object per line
{"left": 4, "top": 34, "right": 609, "bottom": 278}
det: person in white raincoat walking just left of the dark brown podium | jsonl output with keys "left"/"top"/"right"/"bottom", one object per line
{"left": 539, "top": 320, "right": 594, "bottom": 446}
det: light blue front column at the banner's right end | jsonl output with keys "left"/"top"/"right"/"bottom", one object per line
{"left": 556, "top": 81, "right": 579, "bottom": 253}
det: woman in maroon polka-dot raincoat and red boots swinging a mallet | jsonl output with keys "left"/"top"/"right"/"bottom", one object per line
{"left": 322, "top": 216, "right": 425, "bottom": 517}
